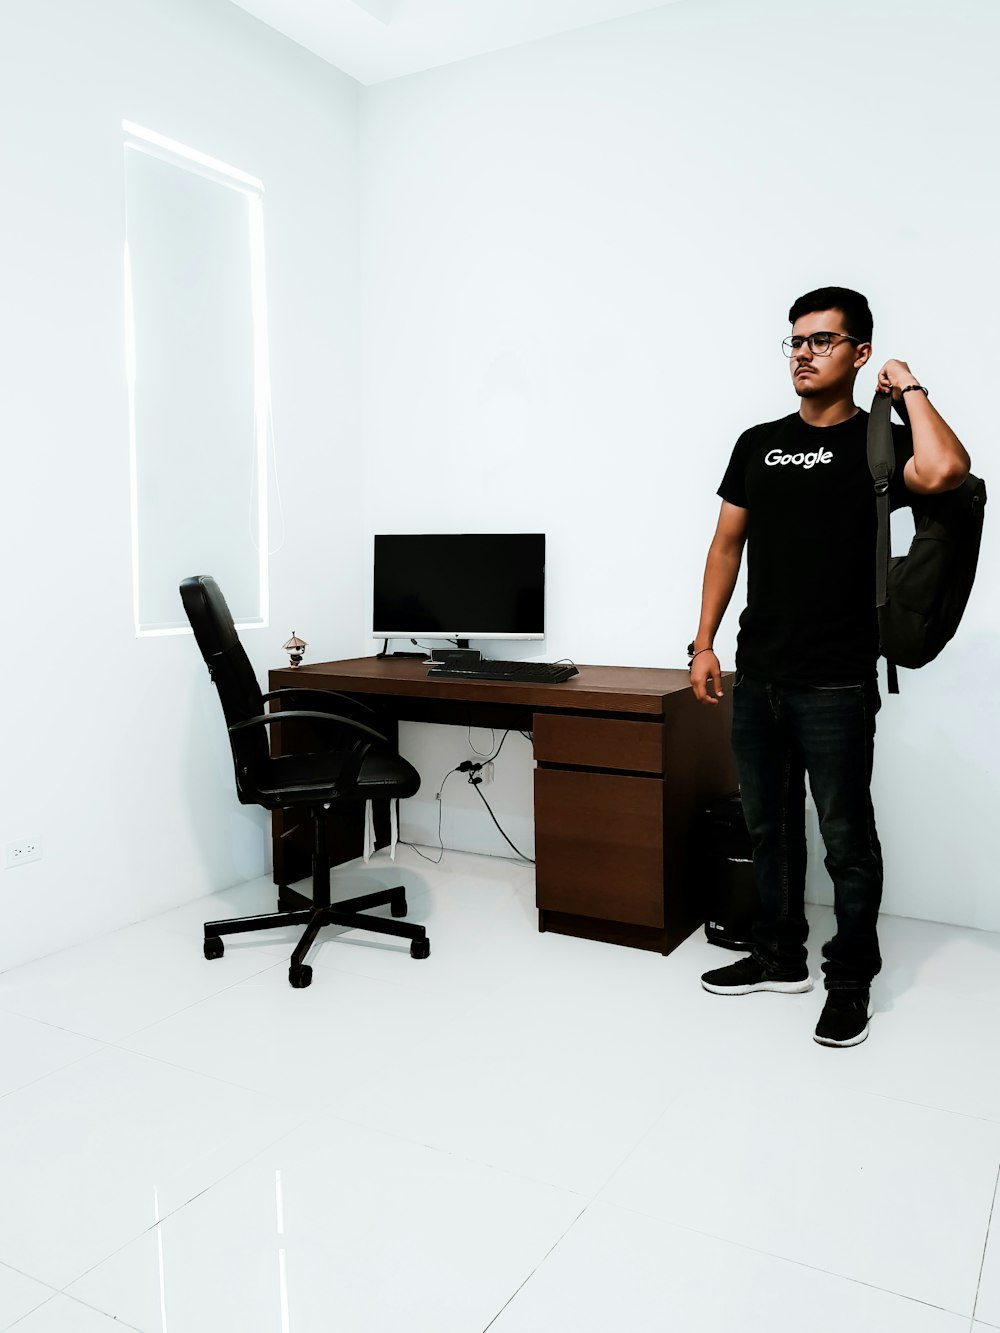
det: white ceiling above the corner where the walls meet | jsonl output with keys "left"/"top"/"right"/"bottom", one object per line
{"left": 224, "top": 0, "right": 677, "bottom": 84}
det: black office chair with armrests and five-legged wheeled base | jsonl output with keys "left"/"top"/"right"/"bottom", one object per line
{"left": 180, "top": 575, "right": 431, "bottom": 988}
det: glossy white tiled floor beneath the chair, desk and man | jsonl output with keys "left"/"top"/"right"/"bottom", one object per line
{"left": 0, "top": 849, "right": 1000, "bottom": 1333}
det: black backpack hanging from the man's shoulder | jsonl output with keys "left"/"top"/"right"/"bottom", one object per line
{"left": 868, "top": 393, "right": 987, "bottom": 694}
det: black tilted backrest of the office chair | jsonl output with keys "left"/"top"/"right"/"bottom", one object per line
{"left": 180, "top": 575, "right": 269, "bottom": 789}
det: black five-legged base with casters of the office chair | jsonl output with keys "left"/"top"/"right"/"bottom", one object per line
{"left": 204, "top": 806, "right": 431, "bottom": 989}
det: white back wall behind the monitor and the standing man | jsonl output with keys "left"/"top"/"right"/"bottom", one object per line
{"left": 361, "top": 0, "right": 1000, "bottom": 929}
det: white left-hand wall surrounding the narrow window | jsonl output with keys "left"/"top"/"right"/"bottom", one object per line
{"left": 0, "top": 0, "right": 364, "bottom": 968}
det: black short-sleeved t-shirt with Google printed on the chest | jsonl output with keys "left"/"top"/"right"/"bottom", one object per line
{"left": 719, "top": 411, "right": 913, "bottom": 684}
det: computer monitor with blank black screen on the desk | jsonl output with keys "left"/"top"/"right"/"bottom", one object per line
{"left": 372, "top": 532, "right": 545, "bottom": 641}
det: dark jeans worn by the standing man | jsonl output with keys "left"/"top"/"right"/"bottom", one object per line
{"left": 732, "top": 673, "right": 883, "bottom": 990}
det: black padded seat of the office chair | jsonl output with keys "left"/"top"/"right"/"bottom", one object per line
{"left": 255, "top": 745, "right": 420, "bottom": 809}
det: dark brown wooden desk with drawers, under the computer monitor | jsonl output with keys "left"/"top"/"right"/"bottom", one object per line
{"left": 269, "top": 657, "right": 737, "bottom": 953}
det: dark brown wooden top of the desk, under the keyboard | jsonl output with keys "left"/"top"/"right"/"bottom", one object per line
{"left": 269, "top": 657, "right": 691, "bottom": 717}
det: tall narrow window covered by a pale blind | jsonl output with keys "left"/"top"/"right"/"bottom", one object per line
{"left": 124, "top": 121, "right": 271, "bottom": 636}
